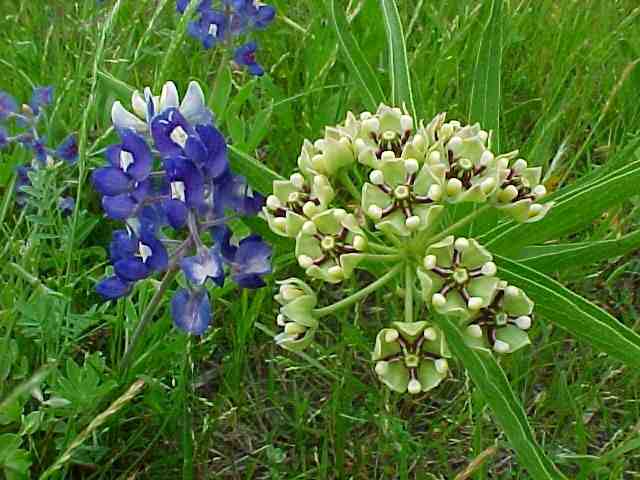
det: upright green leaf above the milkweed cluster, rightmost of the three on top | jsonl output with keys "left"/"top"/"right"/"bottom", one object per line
{"left": 469, "top": 0, "right": 503, "bottom": 152}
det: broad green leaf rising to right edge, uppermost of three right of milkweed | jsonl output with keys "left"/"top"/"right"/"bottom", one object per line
{"left": 480, "top": 161, "right": 640, "bottom": 256}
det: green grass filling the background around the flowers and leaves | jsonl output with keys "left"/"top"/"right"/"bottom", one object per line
{"left": 0, "top": 0, "right": 640, "bottom": 479}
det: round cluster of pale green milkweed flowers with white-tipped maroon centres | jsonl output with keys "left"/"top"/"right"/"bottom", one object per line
{"left": 263, "top": 105, "right": 552, "bottom": 394}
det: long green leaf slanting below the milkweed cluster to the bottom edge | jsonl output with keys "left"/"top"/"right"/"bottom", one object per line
{"left": 436, "top": 316, "right": 566, "bottom": 480}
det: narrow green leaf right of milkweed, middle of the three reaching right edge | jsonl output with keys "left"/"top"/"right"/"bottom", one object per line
{"left": 516, "top": 230, "right": 640, "bottom": 272}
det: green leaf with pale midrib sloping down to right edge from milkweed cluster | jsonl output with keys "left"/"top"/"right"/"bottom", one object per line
{"left": 495, "top": 256, "right": 640, "bottom": 368}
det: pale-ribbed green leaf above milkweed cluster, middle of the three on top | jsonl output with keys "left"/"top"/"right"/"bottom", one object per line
{"left": 380, "top": 0, "right": 417, "bottom": 118}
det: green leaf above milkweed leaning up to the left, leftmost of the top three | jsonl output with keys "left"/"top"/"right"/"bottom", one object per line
{"left": 331, "top": 0, "right": 385, "bottom": 112}
